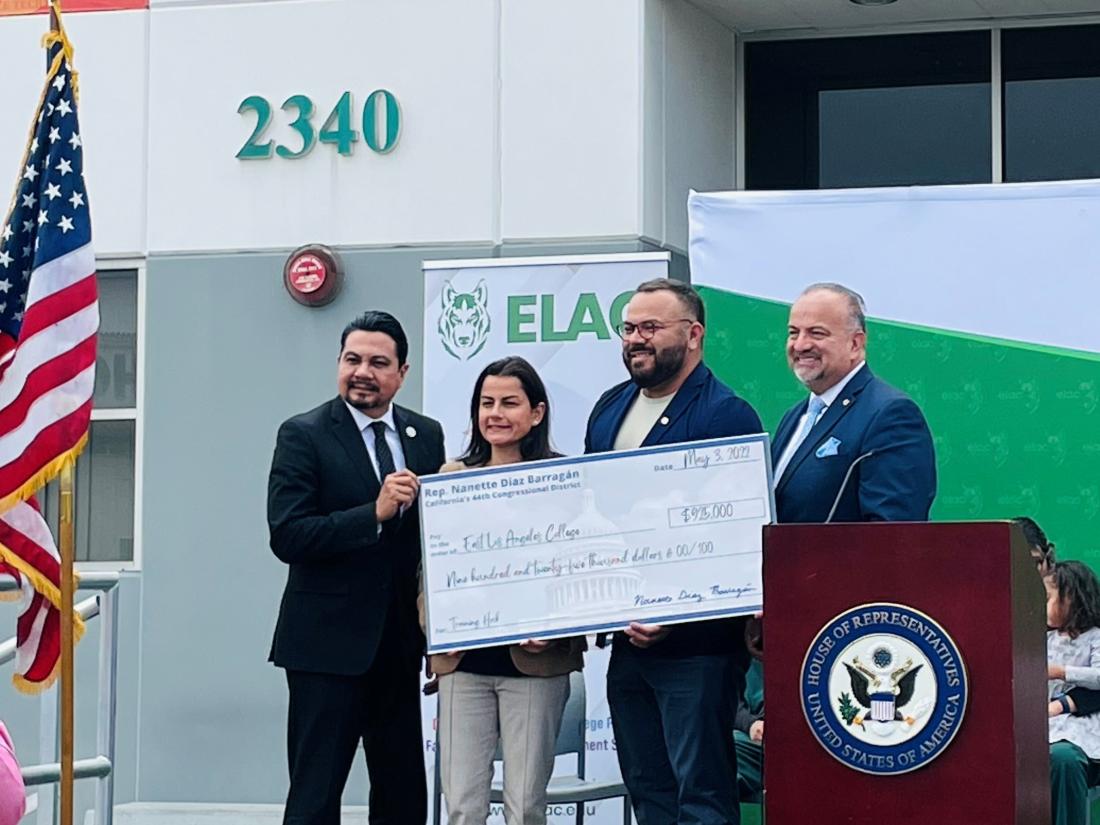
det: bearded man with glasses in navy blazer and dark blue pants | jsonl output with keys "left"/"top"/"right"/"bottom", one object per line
{"left": 584, "top": 278, "right": 761, "bottom": 825}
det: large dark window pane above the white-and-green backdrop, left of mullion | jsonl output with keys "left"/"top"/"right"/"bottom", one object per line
{"left": 745, "top": 31, "right": 992, "bottom": 189}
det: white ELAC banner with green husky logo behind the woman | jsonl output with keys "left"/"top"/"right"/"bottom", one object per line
{"left": 421, "top": 252, "right": 670, "bottom": 825}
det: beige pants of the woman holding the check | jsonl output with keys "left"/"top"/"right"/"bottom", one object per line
{"left": 439, "top": 671, "right": 569, "bottom": 825}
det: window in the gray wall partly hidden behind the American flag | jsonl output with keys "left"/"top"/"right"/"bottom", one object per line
{"left": 43, "top": 270, "right": 139, "bottom": 567}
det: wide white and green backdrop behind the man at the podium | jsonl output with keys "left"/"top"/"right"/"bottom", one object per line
{"left": 689, "top": 182, "right": 1100, "bottom": 568}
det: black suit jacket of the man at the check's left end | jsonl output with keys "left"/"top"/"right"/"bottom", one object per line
{"left": 267, "top": 397, "right": 444, "bottom": 675}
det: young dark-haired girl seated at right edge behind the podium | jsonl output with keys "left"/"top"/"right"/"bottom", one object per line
{"left": 1043, "top": 561, "right": 1100, "bottom": 825}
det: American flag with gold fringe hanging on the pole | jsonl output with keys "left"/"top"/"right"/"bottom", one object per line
{"left": 0, "top": 23, "right": 99, "bottom": 690}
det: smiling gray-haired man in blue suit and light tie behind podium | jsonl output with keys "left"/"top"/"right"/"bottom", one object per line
{"left": 771, "top": 284, "right": 936, "bottom": 523}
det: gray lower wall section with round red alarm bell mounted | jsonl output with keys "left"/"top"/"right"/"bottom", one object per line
{"left": 130, "top": 241, "right": 682, "bottom": 804}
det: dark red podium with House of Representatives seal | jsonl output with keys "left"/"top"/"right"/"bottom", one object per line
{"left": 763, "top": 521, "right": 1051, "bottom": 825}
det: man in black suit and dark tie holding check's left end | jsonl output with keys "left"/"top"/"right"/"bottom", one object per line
{"left": 267, "top": 311, "right": 444, "bottom": 825}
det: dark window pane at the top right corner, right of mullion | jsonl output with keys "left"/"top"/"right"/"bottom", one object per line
{"left": 1001, "top": 25, "right": 1100, "bottom": 180}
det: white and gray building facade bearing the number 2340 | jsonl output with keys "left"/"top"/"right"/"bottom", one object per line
{"left": 0, "top": 0, "right": 1100, "bottom": 822}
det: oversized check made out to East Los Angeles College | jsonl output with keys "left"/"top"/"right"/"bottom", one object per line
{"left": 420, "top": 435, "right": 774, "bottom": 652}
